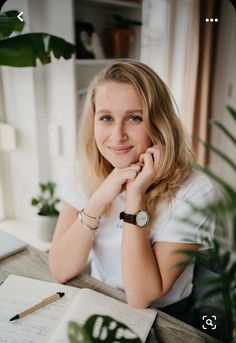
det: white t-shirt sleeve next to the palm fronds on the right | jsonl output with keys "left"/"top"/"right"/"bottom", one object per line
{"left": 150, "top": 174, "right": 216, "bottom": 250}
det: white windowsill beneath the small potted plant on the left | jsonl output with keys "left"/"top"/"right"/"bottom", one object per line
{"left": 0, "top": 219, "right": 51, "bottom": 251}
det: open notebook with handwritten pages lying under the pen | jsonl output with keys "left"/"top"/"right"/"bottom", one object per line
{"left": 0, "top": 275, "right": 157, "bottom": 343}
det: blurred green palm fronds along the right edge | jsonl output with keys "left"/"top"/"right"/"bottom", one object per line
{"left": 179, "top": 106, "right": 236, "bottom": 343}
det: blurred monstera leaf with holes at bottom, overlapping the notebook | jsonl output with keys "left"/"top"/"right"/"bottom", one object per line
{"left": 68, "top": 315, "right": 141, "bottom": 343}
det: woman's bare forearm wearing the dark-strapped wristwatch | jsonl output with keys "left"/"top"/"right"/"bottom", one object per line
{"left": 122, "top": 196, "right": 162, "bottom": 308}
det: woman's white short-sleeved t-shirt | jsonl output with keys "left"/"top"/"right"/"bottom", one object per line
{"left": 60, "top": 171, "right": 216, "bottom": 308}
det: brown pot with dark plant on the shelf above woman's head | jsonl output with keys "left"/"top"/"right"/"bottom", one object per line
{"left": 104, "top": 14, "right": 142, "bottom": 58}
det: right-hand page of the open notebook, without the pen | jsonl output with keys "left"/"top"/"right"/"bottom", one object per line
{"left": 50, "top": 289, "right": 157, "bottom": 343}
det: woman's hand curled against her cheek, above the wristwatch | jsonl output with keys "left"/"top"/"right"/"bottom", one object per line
{"left": 126, "top": 146, "right": 160, "bottom": 195}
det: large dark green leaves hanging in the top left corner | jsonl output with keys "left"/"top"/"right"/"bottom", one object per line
{"left": 0, "top": 11, "right": 75, "bottom": 67}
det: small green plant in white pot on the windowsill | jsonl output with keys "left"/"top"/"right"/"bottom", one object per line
{"left": 31, "top": 181, "right": 60, "bottom": 241}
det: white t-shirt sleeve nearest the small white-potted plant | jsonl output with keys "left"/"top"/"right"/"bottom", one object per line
{"left": 59, "top": 165, "right": 87, "bottom": 210}
